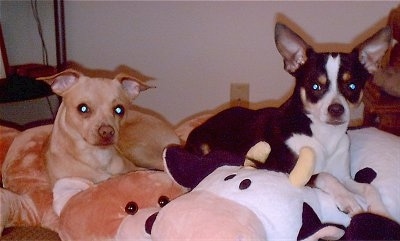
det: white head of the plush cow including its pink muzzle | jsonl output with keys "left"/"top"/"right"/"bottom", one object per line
{"left": 151, "top": 166, "right": 350, "bottom": 240}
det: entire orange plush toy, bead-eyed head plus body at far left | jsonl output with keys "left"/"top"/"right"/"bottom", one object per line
{"left": 0, "top": 125, "right": 186, "bottom": 240}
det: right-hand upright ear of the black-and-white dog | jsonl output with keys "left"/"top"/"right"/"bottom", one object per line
{"left": 356, "top": 26, "right": 392, "bottom": 74}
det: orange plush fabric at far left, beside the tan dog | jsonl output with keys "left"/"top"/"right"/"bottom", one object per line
{"left": 0, "top": 125, "right": 58, "bottom": 230}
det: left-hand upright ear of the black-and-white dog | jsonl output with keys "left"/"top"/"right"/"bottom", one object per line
{"left": 275, "top": 23, "right": 310, "bottom": 73}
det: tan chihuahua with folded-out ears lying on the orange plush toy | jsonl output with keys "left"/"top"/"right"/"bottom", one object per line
{"left": 40, "top": 69, "right": 179, "bottom": 184}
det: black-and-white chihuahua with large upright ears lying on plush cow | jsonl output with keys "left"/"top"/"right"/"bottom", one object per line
{"left": 164, "top": 23, "right": 391, "bottom": 217}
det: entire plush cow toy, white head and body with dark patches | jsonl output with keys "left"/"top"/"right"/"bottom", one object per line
{"left": 151, "top": 128, "right": 400, "bottom": 240}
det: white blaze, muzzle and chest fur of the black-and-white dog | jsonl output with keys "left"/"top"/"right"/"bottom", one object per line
{"left": 286, "top": 55, "right": 350, "bottom": 177}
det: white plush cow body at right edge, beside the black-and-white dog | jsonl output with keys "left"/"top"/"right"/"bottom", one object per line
{"left": 348, "top": 127, "right": 400, "bottom": 223}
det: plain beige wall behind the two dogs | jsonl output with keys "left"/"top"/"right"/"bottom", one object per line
{"left": 2, "top": 1, "right": 398, "bottom": 124}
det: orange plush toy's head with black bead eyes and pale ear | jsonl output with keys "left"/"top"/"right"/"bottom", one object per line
{"left": 54, "top": 170, "right": 186, "bottom": 240}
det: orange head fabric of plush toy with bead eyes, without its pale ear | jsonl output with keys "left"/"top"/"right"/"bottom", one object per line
{"left": 59, "top": 171, "right": 186, "bottom": 240}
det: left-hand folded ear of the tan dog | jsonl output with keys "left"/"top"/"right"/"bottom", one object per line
{"left": 37, "top": 69, "right": 82, "bottom": 96}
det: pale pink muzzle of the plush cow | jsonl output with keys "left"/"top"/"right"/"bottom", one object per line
{"left": 151, "top": 191, "right": 267, "bottom": 241}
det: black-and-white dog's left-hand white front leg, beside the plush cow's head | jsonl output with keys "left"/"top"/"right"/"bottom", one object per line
{"left": 313, "top": 172, "right": 363, "bottom": 216}
